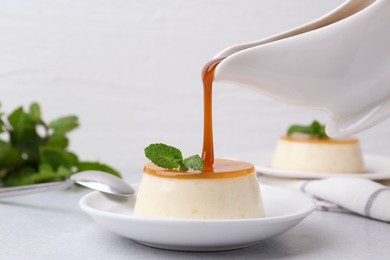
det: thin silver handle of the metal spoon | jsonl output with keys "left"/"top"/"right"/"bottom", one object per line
{"left": 0, "top": 179, "right": 74, "bottom": 199}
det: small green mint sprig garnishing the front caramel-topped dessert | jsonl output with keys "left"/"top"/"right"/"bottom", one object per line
{"left": 145, "top": 143, "right": 204, "bottom": 171}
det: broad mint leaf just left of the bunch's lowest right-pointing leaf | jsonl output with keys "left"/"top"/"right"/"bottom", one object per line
{"left": 39, "top": 146, "right": 78, "bottom": 170}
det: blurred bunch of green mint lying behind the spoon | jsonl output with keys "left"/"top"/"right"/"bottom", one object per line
{"left": 0, "top": 103, "right": 120, "bottom": 186}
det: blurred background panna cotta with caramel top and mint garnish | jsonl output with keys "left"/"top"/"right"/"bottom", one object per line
{"left": 271, "top": 121, "right": 364, "bottom": 173}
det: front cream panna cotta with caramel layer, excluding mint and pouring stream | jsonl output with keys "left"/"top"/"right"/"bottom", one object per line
{"left": 134, "top": 159, "right": 264, "bottom": 219}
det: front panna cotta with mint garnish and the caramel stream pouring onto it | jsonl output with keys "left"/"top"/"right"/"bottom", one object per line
{"left": 134, "top": 58, "right": 264, "bottom": 219}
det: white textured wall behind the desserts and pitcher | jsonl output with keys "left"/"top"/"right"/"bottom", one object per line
{"left": 0, "top": 0, "right": 390, "bottom": 175}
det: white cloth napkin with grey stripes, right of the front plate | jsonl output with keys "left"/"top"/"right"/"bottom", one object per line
{"left": 260, "top": 176, "right": 390, "bottom": 222}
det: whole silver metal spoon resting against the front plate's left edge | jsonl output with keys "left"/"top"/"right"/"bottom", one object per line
{"left": 0, "top": 171, "right": 134, "bottom": 199}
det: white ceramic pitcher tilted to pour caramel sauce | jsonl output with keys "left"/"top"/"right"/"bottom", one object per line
{"left": 214, "top": 0, "right": 390, "bottom": 136}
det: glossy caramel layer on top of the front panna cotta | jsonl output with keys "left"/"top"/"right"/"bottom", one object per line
{"left": 144, "top": 159, "right": 255, "bottom": 179}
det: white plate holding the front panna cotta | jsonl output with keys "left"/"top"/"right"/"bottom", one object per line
{"left": 79, "top": 185, "right": 314, "bottom": 251}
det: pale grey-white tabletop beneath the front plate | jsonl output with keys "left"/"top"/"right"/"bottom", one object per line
{"left": 0, "top": 171, "right": 390, "bottom": 260}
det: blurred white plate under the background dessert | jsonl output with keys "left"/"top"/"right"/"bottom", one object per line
{"left": 235, "top": 153, "right": 390, "bottom": 180}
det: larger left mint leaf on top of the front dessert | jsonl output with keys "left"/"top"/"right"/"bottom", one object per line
{"left": 145, "top": 143, "right": 183, "bottom": 169}
